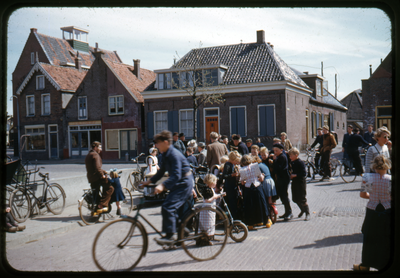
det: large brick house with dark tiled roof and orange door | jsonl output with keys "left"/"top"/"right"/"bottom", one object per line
{"left": 142, "top": 30, "right": 347, "bottom": 149}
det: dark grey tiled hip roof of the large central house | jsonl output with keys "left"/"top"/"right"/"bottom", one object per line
{"left": 171, "top": 43, "right": 308, "bottom": 88}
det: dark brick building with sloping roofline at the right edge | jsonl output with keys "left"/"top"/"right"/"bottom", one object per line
{"left": 361, "top": 52, "right": 393, "bottom": 131}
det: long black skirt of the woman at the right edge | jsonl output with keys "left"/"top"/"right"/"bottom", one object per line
{"left": 361, "top": 204, "right": 393, "bottom": 270}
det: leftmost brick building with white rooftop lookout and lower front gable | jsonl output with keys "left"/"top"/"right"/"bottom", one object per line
{"left": 12, "top": 26, "right": 129, "bottom": 159}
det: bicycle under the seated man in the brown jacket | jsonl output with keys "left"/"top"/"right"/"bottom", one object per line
{"left": 78, "top": 171, "right": 133, "bottom": 225}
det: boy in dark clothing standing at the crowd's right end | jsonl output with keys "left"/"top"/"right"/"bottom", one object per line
{"left": 288, "top": 148, "right": 310, "bottom": 221}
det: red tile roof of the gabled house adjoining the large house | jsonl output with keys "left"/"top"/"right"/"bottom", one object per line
{"left": 103, "top": 58, "right": 156, "bottom": 102}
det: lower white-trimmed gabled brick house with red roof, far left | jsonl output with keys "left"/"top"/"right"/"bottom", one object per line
{"left": 16, "top": 62, "right": 87, "bottom": 159}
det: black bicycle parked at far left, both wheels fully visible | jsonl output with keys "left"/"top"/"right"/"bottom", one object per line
{"left": 10, "top": 167, "right": 66, "bottom": 223}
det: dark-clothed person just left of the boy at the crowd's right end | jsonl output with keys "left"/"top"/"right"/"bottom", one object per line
{"left": 273, "top": 144, "right": 293, "bottom": 221}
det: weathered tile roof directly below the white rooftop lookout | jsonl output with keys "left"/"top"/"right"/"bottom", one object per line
{"left": 35, "top": 33, "right": 122, "bottom": 67}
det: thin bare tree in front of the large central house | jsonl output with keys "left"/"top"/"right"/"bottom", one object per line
{"left": 171, "top": 42, "right": 226, "bottom": 140}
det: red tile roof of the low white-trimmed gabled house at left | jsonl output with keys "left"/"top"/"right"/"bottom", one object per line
{"left": 40, "top": 63, "right": 88, "bottom": 91}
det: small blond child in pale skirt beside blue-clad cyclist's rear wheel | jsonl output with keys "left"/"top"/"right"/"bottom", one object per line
{"left": 196, "top": 174, "right": 225, "bottom": 245}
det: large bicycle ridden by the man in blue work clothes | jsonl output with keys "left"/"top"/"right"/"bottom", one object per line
{"left": 92, "top": 194, "right": 229, "bottom": 271}
